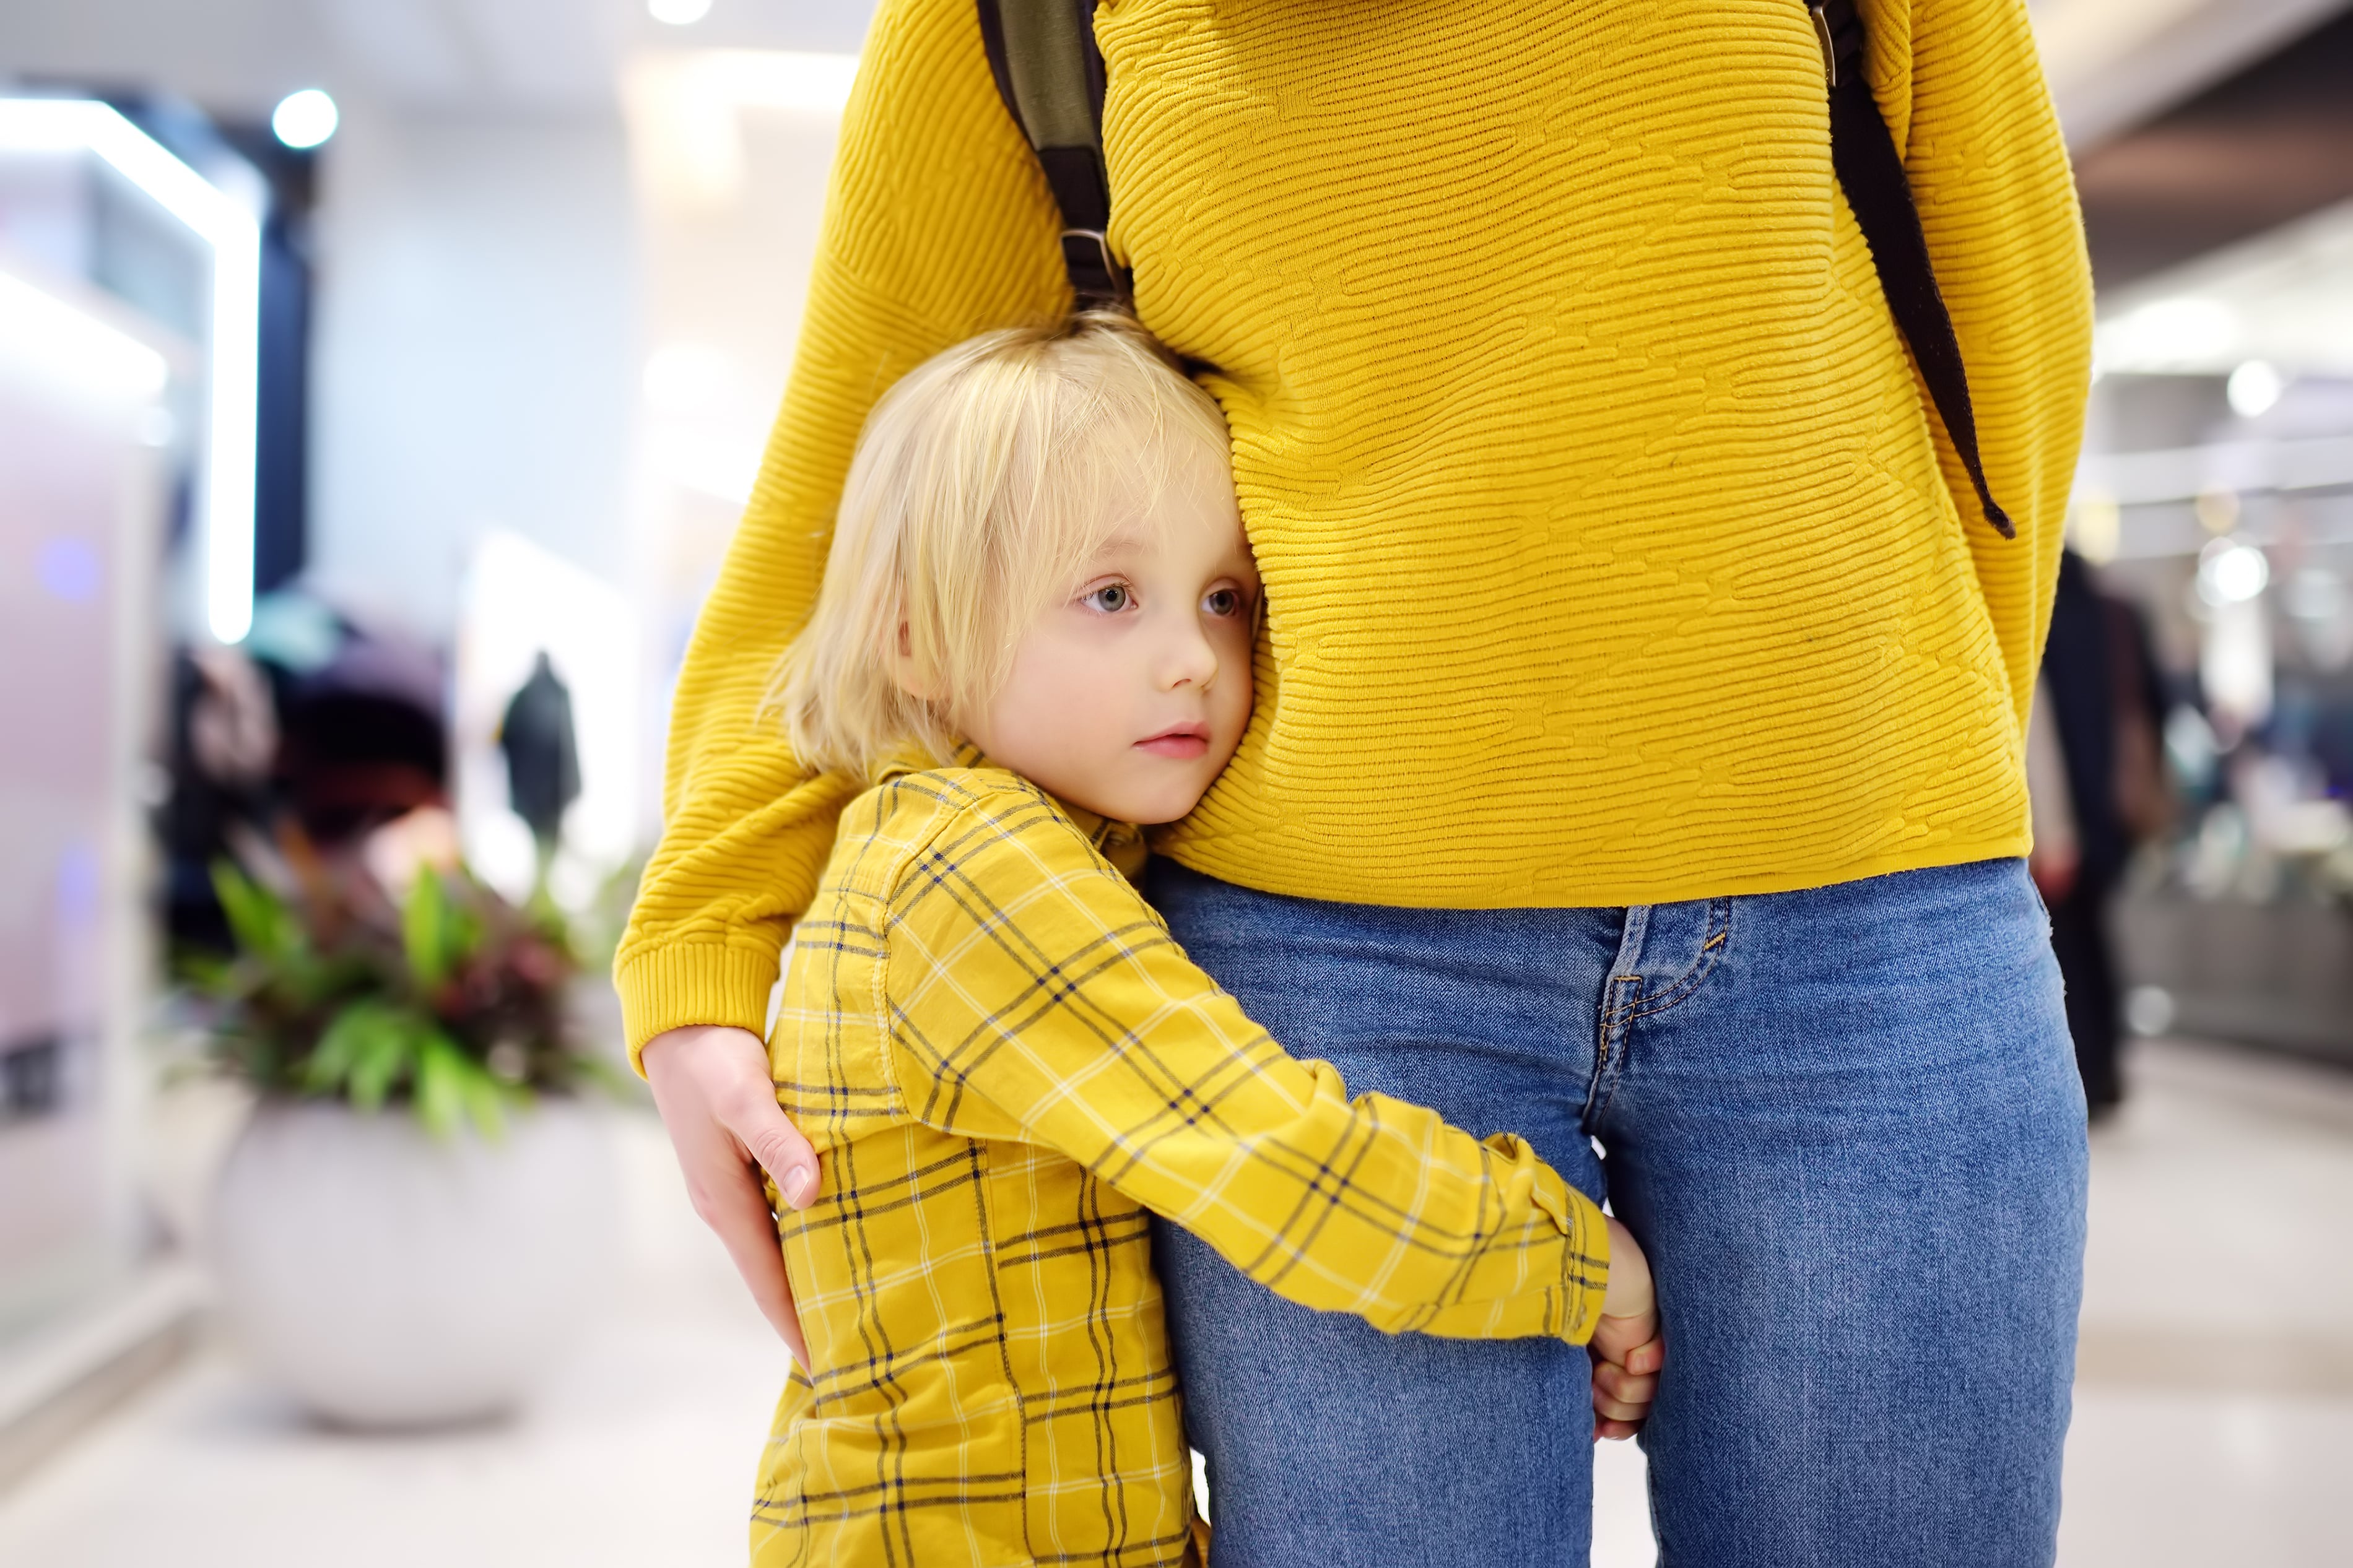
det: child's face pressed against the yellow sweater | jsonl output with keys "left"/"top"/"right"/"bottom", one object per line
{"left": 965, "top": 441, "right": 1259, "bottom": 823}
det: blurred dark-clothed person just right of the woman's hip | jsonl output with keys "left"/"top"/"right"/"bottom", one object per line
{"left": 2029, "top": 550, "right": 2172, "bottom": 1121}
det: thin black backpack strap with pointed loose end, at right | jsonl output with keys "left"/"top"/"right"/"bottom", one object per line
{"left": 1807, "top": 0, "right": 2019, "bottom": 539}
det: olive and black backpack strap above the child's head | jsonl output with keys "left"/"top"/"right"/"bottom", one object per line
{"left": 979, "top": 0, "right": 1127, "bottom": 310}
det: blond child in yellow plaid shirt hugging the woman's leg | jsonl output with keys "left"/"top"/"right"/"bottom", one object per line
{"left": 753, "top": 315, "right": 1650, "bottom": 1568}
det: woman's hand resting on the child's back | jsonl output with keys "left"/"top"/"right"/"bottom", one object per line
{"left": 642, "top": 1025, "right": 817, "bottom": 1368}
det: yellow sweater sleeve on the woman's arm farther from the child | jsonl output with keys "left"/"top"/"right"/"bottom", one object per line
{"left": 1861, "top": 0, "right": 2092, "bottom": 736}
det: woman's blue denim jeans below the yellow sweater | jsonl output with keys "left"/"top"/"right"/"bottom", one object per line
{"left": 1150, "top": 860, "right": 2085, "bottom": 1568}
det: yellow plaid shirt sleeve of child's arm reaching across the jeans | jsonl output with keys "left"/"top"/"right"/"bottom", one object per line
{"left": 885, "top": 792, "right": 1607, "bottom": 1345}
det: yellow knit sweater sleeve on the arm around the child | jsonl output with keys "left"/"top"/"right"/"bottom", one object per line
{"left": 614, "top": 0, "right": 1068, "bottom": 1060}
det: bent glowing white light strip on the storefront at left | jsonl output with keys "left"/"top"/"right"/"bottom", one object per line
{"left": 0, "top": 98, "right": 261, "bottom": 642}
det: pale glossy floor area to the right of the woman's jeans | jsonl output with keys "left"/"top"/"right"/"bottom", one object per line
{"left": 2059, "top": 1046, "right": 2353, "bottom": 1568}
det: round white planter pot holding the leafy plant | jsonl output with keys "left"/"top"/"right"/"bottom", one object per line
{"left": 212, "top": 1102, "right": 614, "bottom": 1427}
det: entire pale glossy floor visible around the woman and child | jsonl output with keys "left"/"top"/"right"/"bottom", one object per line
{"left": 0, "top": 1046, "right": 2353, "bottom": 1568}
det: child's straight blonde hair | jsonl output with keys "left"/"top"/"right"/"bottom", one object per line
{"left": 770, "top": 310, "right": 1229, "bottom": 769}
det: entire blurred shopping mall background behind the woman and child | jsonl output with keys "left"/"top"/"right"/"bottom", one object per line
{"left": 0, "top": 0, "right": 2353, "bottom": 1568}
